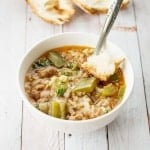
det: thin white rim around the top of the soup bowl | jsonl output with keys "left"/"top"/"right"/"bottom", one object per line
{"left": 17, "top": 32, "right": 134, "bottom": 124}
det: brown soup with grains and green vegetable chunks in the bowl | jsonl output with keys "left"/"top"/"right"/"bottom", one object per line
{"left": 24, "top": 46, "right": 125, "bottom": 120}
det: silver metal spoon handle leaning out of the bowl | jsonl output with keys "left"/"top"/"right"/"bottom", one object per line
{"left": 94, "top": 0, "right": 123, "bottom": 55}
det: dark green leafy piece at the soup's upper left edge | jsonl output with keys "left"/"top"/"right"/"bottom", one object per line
{"left": 32, "top": 58, "right": 51, "bottom": 69}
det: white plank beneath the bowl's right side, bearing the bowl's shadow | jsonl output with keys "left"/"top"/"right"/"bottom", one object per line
{"left": 105, "top": 0, "right": 150, "bottom": 150}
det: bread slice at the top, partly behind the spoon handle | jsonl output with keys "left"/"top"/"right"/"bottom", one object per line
{"left": 73, "top": 0, "right": 130, "bottom": 14}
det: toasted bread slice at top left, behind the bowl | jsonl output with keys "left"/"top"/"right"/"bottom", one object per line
{"left": 26, "top": 0, "right": 75, "bottom": 24}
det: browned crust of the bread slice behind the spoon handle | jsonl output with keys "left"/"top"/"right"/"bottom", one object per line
{"left": 73, "top": 0, "right": 130, "bottom": 14}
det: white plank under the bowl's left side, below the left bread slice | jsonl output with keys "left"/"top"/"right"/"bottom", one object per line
{"left": 22, "top": 4, "right": 64, "bottom": 150}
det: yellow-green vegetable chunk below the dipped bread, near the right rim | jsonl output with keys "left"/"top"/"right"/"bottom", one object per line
{"left": 101, "top": 83, "right": 118, "bottom": 96}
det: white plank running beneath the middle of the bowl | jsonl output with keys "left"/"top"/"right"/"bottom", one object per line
{"left": 63, "top": 5, "right": 107, "bottom": 150}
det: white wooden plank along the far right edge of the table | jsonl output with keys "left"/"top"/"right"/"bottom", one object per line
{"left": 134, "top": 0, "right": 150, "bottom": 127}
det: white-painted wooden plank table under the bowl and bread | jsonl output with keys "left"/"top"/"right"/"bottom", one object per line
{"left": 0, "top": 0, "right": 150, "bottom": 150}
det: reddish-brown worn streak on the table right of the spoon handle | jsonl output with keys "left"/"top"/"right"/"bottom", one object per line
{"left": 113, "top": 26, "right": 137, "bottom": 32}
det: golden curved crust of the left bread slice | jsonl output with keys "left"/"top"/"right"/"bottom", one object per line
{"left": 25, "top": 0, "right": 75, "bottom": 24}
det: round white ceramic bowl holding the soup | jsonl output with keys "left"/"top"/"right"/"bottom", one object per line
{"left": 18, "top": 33, "right": 134, "bottom": 133}
